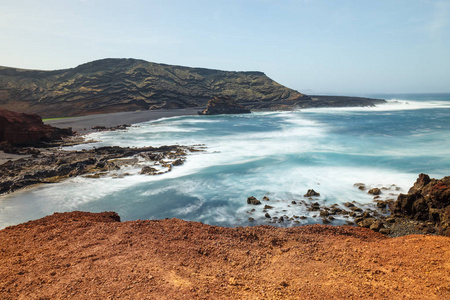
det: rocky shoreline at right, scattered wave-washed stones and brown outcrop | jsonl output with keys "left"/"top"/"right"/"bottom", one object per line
{"left": 247, "top": 174, "right": 450, "bottom": 237}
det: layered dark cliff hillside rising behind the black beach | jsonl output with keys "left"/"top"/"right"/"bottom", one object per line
{"left": 0, "top": 59, "right": 310, "bottom": 117}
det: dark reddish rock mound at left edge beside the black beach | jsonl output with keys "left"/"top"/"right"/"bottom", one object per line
{"left": 0, "top": 108, "right": 72, "bottom": 146}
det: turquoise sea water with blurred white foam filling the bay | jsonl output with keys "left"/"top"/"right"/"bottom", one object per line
{"left": 0, "top": 94, "right": 450, "bottom": 228}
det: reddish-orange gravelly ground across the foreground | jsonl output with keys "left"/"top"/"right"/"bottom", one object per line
{"left": 0, "top": 212, "right": 450, "bottom": 299}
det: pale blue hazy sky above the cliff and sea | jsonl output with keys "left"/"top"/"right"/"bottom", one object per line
{"left": 0, "top": 0, "right": 450, "bottom": 95}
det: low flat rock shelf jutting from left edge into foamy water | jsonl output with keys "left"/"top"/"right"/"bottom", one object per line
{"left": 0, "top": 146, "right": 192, "bottom": 195}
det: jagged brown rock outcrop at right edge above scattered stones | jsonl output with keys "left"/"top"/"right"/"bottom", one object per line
{"left": 391, "top": 174, "right": 450, "bottom": 236}
